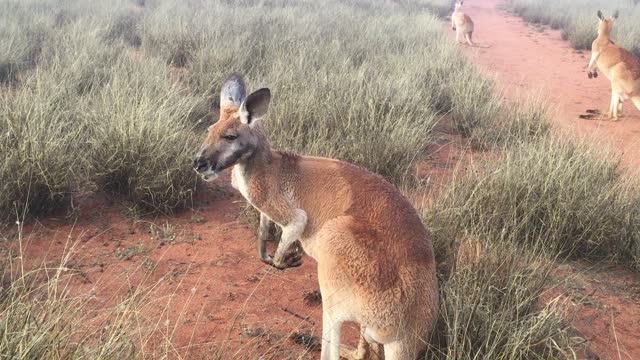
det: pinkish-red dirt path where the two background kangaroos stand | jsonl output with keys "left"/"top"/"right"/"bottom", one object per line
{"left": 456, "top": 0, "right": 640, "bottom": 169}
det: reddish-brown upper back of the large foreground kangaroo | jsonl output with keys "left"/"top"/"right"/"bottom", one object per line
{"left": 285, "top": 155, "right": 427, "bottom": 249}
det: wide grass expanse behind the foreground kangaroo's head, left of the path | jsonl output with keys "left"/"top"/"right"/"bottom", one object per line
{"left": 0, "top": 0, "right": 552, "bottom": 219}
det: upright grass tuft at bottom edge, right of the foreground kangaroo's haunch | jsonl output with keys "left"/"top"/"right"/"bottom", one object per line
{"left": 425, "top": 238, "right": 576, "bottom": 359}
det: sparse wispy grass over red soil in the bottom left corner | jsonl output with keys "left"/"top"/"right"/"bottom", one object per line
{"left": 0, "top": 225, "right": 140, "bottom": 360}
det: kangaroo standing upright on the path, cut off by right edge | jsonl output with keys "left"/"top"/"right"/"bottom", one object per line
{"left": 587, "top": 10, "right": 640, "bottom": 121}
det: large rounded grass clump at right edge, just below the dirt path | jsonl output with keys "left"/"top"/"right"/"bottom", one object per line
{"left": 429, "top": 139, "right": 640, "bottom": 269}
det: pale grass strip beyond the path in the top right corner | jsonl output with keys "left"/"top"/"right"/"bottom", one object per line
{"left": 506, "top": 0, "right": 640, "bottom": 56}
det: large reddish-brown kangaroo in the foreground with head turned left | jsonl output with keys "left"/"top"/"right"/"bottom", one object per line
{"left": 194, "top": 74, "right": 439, "bottom": 360}
